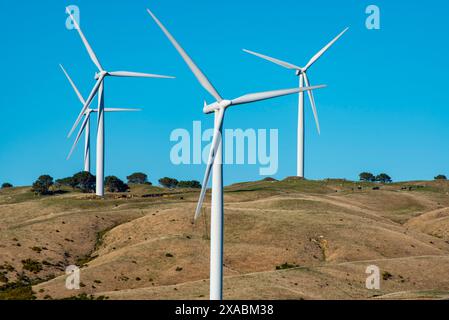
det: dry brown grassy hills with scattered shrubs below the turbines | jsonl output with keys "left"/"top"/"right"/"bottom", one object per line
{"left": 0, "top": 178, "right": 449, "bottom": 299}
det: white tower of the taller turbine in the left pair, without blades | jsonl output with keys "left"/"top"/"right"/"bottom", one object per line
{"left": 96, "top": 82, "right": 104, "bottom": 197}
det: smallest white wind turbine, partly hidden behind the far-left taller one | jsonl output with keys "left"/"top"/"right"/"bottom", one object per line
{"left": 59, "top": 64, "right": 141, "bottom": 172}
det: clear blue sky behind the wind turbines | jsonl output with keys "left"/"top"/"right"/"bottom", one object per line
{"left": 0, "top": 0, "right": 449, "bottom": 185}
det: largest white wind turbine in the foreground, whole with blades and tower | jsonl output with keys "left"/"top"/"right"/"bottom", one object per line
{"left": 147, "top": 9, "right": 324, "bottom": 300}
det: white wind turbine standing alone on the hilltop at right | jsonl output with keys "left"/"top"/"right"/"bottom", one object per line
{"left": 243, "top": 28, "right": 349, "bottom": 178}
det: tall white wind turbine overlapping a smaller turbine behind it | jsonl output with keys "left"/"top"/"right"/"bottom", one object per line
{"left": 66, "top": 8, "right": 174, "bottom": 197}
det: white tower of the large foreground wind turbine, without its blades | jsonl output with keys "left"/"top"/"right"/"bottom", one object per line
{"left": 210, "top": 111, "right": 224, "bottom": 300}
